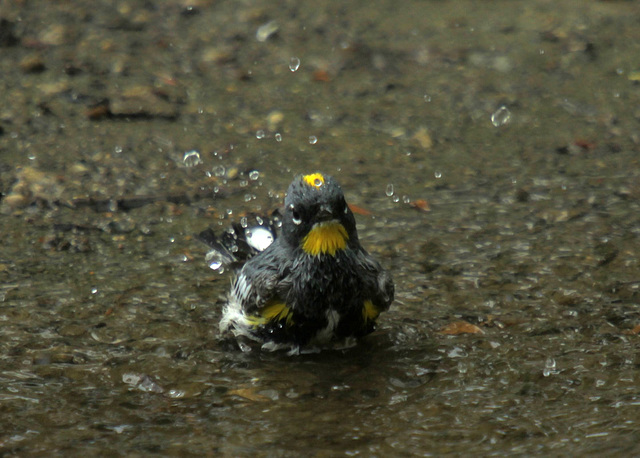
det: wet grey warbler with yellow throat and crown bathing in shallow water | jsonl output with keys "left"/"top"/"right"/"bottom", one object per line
{"left": 200, "top": 173, "right": 394, "bottom": 353}
